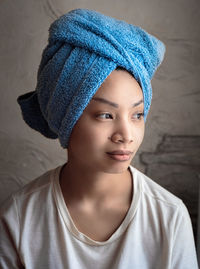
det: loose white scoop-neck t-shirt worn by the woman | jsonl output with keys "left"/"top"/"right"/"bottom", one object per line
{"left": 0, "top": 166, "right": 198, "bottom": 269}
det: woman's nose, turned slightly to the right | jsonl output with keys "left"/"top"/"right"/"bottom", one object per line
{"left": 110, "top": 120, "right": 133, "bottom": 144}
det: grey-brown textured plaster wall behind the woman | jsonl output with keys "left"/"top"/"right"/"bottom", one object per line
{"left": 0, "top": 0, "right": 200, "bottom": 241}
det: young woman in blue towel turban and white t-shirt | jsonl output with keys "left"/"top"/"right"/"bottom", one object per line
{"left": 0, "top": 9, "right": 198, "bottom": 269}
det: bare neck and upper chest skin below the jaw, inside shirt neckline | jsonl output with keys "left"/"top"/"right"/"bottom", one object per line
{"left": 61, "top": 163, "right": 132, "bottom": 241}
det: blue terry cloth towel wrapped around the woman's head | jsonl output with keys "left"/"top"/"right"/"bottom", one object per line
{"left": 18, "top": 9, "right": 165, "bottom": 148}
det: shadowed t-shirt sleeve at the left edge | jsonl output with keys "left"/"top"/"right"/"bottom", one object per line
{"left": 0, "top": 195, "right": 25, "bottom": 269}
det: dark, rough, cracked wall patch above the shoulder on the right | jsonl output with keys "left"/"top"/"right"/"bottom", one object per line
{"left": 140, "top": 135, "right": 200, "bottom": 238}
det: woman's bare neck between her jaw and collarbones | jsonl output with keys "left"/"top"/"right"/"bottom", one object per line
{"left": 60, "top": 159, "right": 132, "bottom": 201}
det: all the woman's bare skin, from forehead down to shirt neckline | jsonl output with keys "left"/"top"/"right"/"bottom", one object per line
{"left": 60, "top": 70, "right": 144, "bottom": 241}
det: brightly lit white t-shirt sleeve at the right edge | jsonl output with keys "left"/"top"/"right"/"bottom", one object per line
{"left": 171, "top": 202, "right": 199, "bottom": 269}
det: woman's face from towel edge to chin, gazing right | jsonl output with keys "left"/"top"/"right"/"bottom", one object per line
{"left": 68, "top": 70, "right": 144, "bottom": 173}
